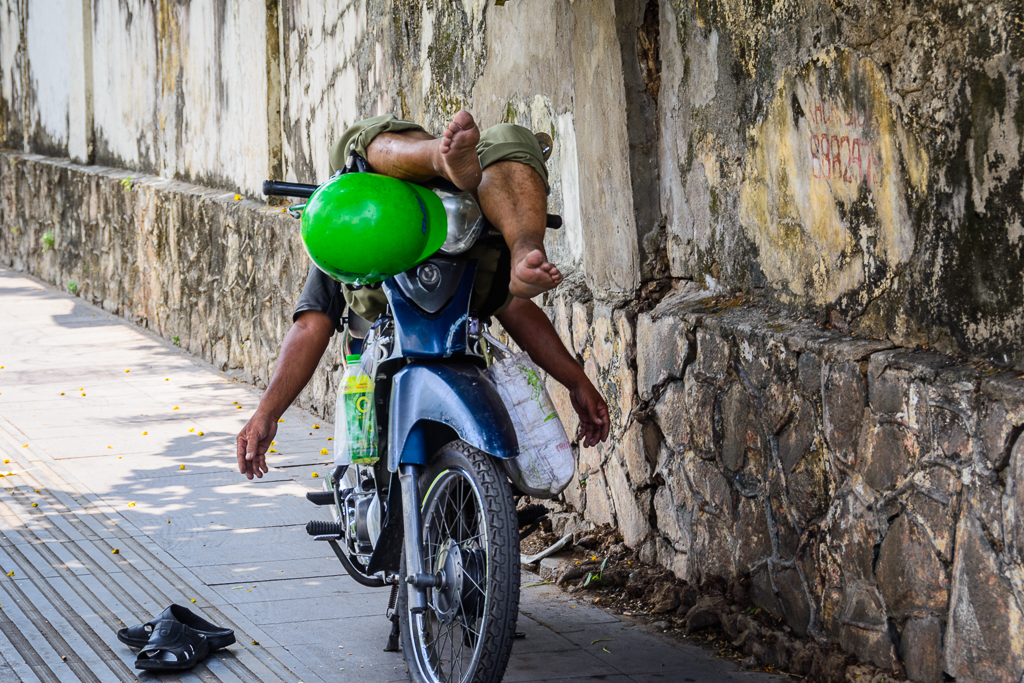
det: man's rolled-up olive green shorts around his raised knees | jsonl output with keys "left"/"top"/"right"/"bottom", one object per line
{"left": 330, "top": 114, "right": 550, "bottom": 188}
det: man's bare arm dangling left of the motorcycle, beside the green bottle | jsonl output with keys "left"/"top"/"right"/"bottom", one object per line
{"left": 236, "top": 310, "right": 334, "bottom": 479}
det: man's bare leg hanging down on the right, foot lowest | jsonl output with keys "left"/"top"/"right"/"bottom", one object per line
{"left": 477, "top": 161, "right": 562, "bottom": 299}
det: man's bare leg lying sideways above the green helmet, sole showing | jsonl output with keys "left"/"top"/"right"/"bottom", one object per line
{"left": 367, "top": 112, "right": 482, "bottom": 193}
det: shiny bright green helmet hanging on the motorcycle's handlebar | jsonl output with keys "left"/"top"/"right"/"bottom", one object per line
{"left": 302, "top": 173, "right": 447, "bottom": 285}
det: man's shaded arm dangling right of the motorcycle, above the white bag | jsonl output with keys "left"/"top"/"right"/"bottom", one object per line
{"left": 497, "top": 298, "right": 610, "bottom": 449}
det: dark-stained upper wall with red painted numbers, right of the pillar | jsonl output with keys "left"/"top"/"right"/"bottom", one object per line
{"left": 659, "top": 0, "right": 1024, "bottom": 366}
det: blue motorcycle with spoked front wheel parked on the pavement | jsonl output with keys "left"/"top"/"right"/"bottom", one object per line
{"left": 263, "top": 155, "right": 561, "bottom": 683}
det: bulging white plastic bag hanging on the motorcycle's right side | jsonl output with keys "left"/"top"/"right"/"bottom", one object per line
{"left": 486, "top": 353, "right": 575, "bottom": 499}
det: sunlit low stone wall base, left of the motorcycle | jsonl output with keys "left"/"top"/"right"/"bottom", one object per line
{"left": 0, "top": 154, "right": 344, "bottom": 419}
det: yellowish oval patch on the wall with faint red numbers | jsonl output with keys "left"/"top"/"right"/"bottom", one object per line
{"left": 740, "top": 50, "right": 928, "bottom": 304}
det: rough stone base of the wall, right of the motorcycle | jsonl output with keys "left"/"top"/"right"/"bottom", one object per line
{"left": 550, "top": 290, "right": 1024, "bottom": 683}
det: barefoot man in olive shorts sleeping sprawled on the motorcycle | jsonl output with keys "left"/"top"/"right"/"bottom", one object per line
{"left": 237, "top": 112, "right": 609, "bottom": 479}
